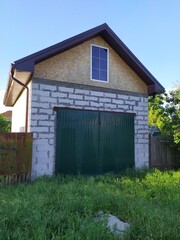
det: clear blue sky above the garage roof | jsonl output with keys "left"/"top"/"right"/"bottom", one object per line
{"left": 0, "top": 0, "right": 180, "bottom": 110}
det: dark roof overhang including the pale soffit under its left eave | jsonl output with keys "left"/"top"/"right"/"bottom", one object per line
{"left": 4, "top": 23, "right": 165, "bottom": 106}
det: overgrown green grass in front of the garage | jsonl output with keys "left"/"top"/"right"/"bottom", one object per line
{"left": 0, "top": 170, "right": 180, "bottom": 240}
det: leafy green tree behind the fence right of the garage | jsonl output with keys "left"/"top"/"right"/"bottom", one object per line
{"left": 148, "top": 86, "right": 180, "bottom": 149}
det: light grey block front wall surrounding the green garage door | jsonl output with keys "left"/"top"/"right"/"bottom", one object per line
{"left": 30, "top": 78, "right": 149, "bottom": 178}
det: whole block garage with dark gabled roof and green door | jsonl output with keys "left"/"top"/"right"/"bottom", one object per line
{"left": 4, "top": 24, "right": 164, "bottom": 177}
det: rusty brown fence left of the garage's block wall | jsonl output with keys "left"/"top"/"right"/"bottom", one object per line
{"left": 0, "top": 133, "right": 32, "bottom": 185}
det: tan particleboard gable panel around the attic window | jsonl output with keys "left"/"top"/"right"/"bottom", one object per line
{"left": 34, "top": 37, "right": 147, "bottom": 93}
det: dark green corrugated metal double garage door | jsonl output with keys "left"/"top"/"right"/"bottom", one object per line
{"left": 55, "top": 109, "right": 134, "bottom": 174}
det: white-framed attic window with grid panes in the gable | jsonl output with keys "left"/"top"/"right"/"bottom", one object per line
{"left": 91, "top": 45, "right": 109, "bottom": 82}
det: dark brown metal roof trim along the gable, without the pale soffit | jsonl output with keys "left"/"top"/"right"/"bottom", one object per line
{"left": 4, "top": 23, "right": 165, "bottom": 105}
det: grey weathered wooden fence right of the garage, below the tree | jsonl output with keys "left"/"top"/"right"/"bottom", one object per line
{"left": 149, "top": 136, "right": 180, "bottom": 170}
